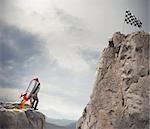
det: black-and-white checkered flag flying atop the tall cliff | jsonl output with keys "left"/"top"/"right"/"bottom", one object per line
{"left": 125, "top": 9, "right": 142, "bottom": 28}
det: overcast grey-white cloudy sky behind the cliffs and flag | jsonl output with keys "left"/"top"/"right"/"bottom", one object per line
{"left": 0, "top": 0, "right": 149, "bottom": 120}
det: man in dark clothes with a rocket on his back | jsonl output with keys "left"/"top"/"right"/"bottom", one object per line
{"left": 30, "top": 78, "right": 40, "bottom": 110}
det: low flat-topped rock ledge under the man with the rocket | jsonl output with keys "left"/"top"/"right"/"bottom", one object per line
{"left": 0, "top": 103, "right": 45, "bottom": 129}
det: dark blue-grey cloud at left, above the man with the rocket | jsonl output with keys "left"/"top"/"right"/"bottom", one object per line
{"left": 0, "top": 22, "right": 54, "bottom": 87}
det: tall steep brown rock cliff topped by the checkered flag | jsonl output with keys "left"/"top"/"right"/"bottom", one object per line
{"left": 76, "top": 31, "right": 150, "bottom": 129}
